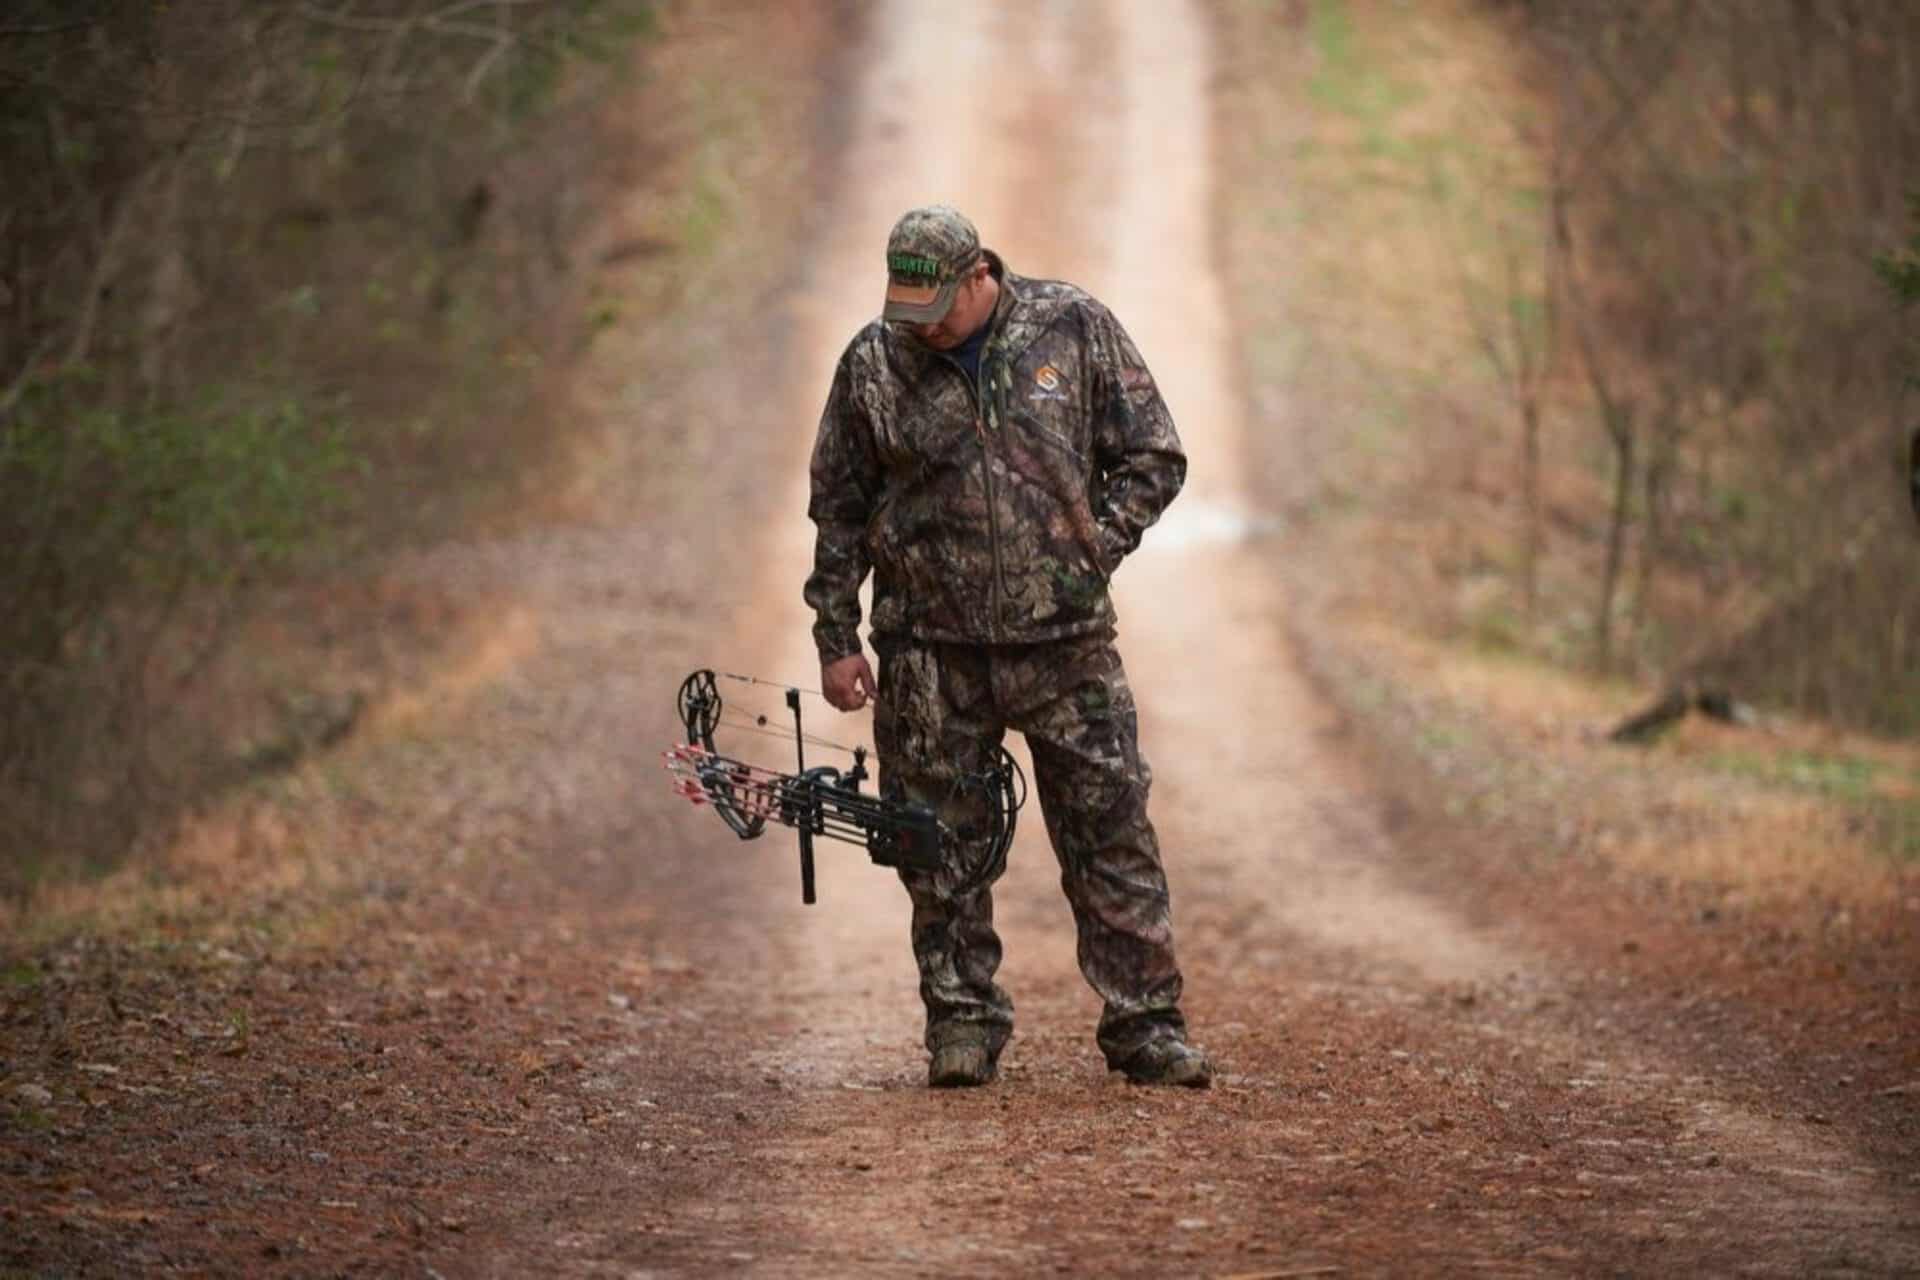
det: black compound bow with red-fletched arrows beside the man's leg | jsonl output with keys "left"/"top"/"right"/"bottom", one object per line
{"left": 662, "top": 668, "right": 1027, "bottom": 904}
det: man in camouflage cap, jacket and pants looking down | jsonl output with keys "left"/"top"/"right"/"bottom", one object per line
{"left": 806, "top": 205, "right": 1212, "bottom": 1086}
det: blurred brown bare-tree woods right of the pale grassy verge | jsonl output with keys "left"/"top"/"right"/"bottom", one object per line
{"left": 1480, "top": 0, "right": 1920, "bottom": 735}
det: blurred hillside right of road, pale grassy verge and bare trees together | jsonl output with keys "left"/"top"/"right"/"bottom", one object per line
{"left": 1223, "top": 0, "right": 1920, "bottom": 737}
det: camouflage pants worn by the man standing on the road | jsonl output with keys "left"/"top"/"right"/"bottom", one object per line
{"left": 874, "top": 633, "right": 1185, "bottom": 1067}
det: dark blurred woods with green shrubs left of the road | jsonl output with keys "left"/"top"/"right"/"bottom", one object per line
{"left": 0, "top": 0, "right": 651, "bottom": 881}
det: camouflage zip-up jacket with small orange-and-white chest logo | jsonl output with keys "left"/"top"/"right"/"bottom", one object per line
{"left": 804, "top": 253, "right": 1187, "bottom": 662}
